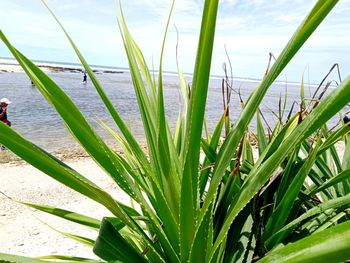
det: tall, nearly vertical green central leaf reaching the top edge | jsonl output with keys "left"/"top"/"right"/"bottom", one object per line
{"left": 180, "top": 0, "right": 218, "bottom": 261}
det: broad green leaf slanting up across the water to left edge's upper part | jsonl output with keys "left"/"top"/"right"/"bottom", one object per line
{"left": 0, "top": 32, "right": 136, "bottom": 198}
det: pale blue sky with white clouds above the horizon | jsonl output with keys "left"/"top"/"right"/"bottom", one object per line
{"left": 0, "top": 0, "right": 350, "bottom": 83}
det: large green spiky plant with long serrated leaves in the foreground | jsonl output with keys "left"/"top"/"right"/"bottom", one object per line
{"left": 0, "top": 0, "right": 350, "bottom": 262}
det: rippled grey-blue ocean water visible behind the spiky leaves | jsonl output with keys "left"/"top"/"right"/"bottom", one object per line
{"left": 0, "top": 71, "right": 339, "bottom": 152}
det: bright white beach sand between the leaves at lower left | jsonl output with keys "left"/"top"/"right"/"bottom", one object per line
{"left": 0, "top": 158, "right": 129, "bottom": 258}
